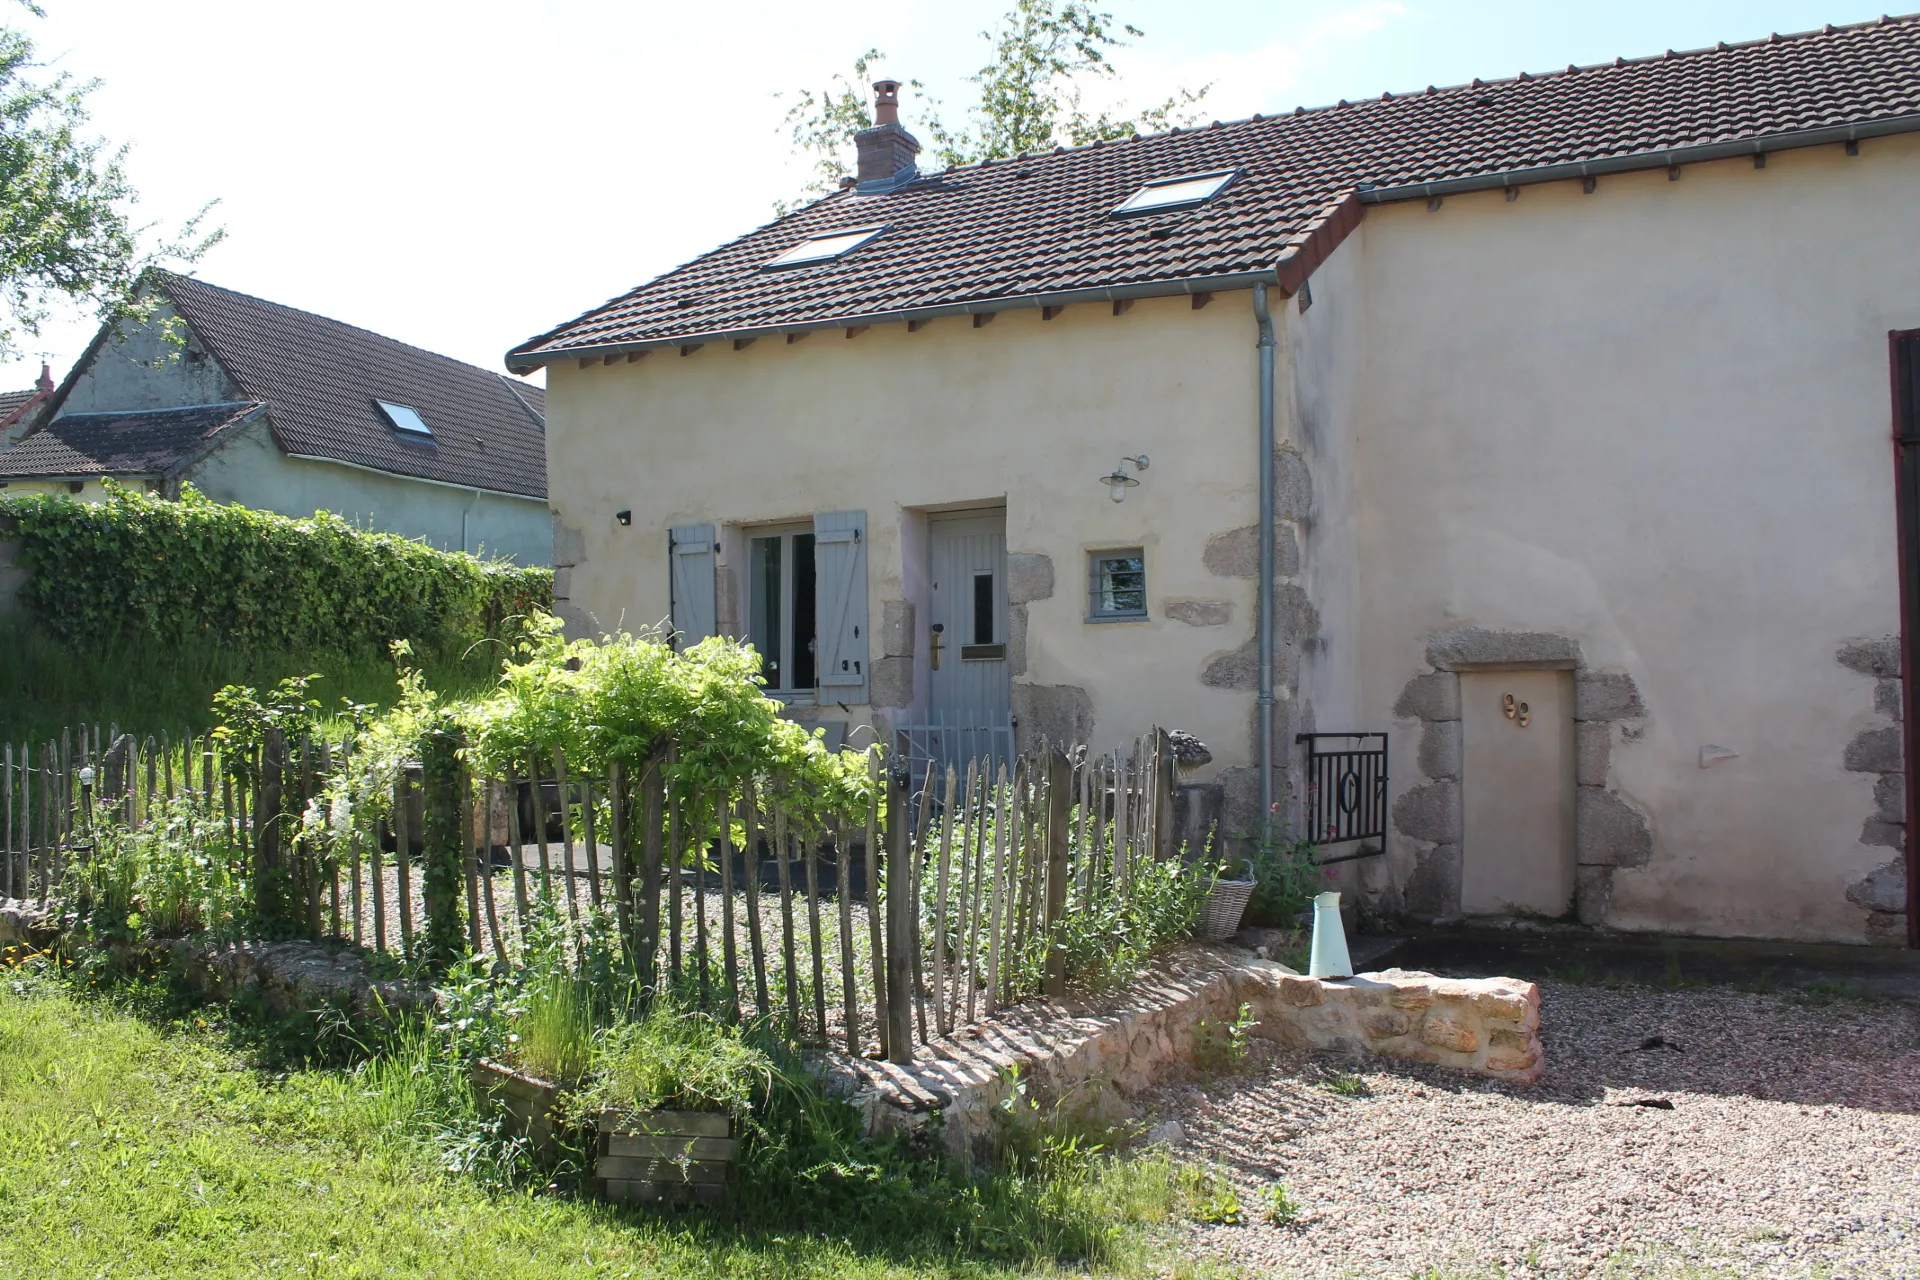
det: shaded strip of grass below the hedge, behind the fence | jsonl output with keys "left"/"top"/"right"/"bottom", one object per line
{"left": 0, "top": 620, "right": 497, "bottom": 743}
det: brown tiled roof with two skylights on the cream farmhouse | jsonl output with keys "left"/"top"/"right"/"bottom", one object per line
{"left": 507, "top": 17, "right": 1920, "bottom": 370}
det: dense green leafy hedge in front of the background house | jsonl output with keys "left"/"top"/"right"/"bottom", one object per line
{"left": 0, "top": 486, "right": 553, "bottom": 652}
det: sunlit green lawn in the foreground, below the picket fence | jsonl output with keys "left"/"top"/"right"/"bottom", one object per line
{"left": 0, "top": 975, "right": 1223, "bottom": 1280}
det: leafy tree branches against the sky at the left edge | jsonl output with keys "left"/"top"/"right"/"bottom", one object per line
{"left": 0, "top": 4, "right": 221, "bottom": 355}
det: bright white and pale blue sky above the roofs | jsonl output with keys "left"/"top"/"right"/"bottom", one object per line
{"left": 0, "top": 0, "right": 1880, "bottom": 390}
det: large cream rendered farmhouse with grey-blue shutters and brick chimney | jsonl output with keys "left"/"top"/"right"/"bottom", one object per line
{"left": 507, "top": 17, "right": 1920, "bottom": 942}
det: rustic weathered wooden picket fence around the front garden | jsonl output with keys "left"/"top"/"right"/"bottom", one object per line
{"left": 0, "top": 727, "right": 1177, "bottom": 1061}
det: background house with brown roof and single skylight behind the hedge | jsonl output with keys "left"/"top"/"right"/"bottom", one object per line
{"left": 0, "top": 273, "right": 551, "bottom": 564}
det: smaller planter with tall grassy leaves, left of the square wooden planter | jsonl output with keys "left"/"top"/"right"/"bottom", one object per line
{"left": 472, "top": 967, "right": 593, "bottom": 1161}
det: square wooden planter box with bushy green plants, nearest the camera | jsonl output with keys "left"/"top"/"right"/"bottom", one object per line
{"left": 580, "top": 1000, "right": 774, "bottom": 1203}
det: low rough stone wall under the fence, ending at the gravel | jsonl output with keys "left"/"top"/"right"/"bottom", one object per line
{"left": 829, "top": 946, "right": 1544, "bottom": 1161}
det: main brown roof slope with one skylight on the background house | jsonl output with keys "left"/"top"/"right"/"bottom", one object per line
{"left": 157, "top": 274, "right": 547, "bottom": 497}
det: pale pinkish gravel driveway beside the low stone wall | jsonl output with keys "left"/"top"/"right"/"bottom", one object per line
{"left": 1148, "top": 983, "right": 1920, "bottom": 1280}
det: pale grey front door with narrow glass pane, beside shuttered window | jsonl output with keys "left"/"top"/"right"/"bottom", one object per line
{"left": 914, "top": 510, "right": 1014, "bottom": 766}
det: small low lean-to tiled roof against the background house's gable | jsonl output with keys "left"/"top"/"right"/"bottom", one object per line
{"left": 0, "top": 401, "right": 259, "bottom": 480}
